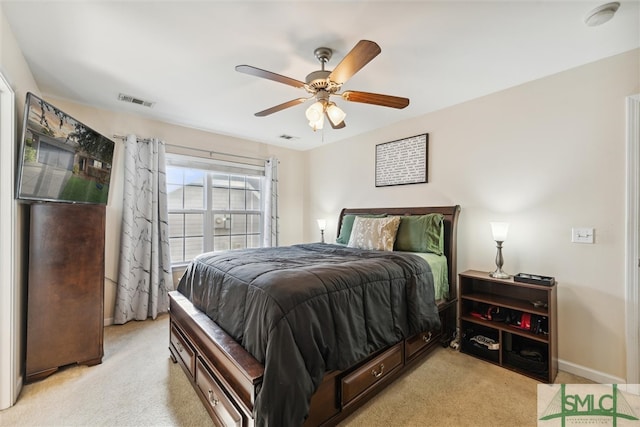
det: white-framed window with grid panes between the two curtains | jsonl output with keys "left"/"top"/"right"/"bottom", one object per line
{"left": 167, "top": 154, "right": 265, "bottom": 265}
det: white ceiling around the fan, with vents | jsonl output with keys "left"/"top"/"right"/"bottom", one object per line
{"left": 0, "top": 0, "right": 640, "bottom": 150}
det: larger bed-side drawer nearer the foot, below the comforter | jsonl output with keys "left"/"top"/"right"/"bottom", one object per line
{"left": 341, "top": 342, "right": 403, "bottom": 406}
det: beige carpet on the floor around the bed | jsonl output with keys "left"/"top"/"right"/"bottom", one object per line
{"left": 0, "top": 315, "right": 586, "bottom": 427}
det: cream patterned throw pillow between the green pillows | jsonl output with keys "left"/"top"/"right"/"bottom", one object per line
{"left": 347, "top": 216, "right": 400, "bottom": 251}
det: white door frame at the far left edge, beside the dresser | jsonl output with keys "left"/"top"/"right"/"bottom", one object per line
{"left": 0, "top": 73, "right": 21, "bottom": 409}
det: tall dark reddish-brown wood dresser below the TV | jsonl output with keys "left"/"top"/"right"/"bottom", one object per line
{"left": 26, "top": 203, "right": 105, "bottom": 382}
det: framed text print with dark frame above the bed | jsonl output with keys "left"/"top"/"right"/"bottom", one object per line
{"left": 376, "top": 133, "right": 429, "bottom": 187}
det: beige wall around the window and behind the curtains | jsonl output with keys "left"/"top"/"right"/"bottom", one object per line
{"left": 43, "top": 98, "right": 304, "bottom": 322}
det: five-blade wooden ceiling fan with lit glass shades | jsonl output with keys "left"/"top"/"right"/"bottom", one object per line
{"left": 236, "top": 40, "right": 409, "bottom": 131}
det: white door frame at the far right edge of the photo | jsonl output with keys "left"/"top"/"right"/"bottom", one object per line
{"left": 625, "top": 94, "right": 640, "bottom": 384}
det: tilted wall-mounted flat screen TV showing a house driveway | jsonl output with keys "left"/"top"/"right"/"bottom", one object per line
{"left": 17, "top": 93, "right": 115, "bottom": 204}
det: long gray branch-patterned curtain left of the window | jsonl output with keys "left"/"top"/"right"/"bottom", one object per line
{"left": 114, "top": 135, "right": 173, "bottom": 324}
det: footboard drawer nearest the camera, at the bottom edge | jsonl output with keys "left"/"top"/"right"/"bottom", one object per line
{"left": 196, "top": 358, "right": 243, "bottom": 427}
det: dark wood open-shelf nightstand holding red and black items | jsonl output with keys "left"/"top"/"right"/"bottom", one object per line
{"left": 458, "top": 270, "right": 558, "bottom": 383}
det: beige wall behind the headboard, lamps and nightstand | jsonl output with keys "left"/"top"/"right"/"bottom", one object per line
{"left": 305, "top": 50, "right": 640, "bottom": 382}
